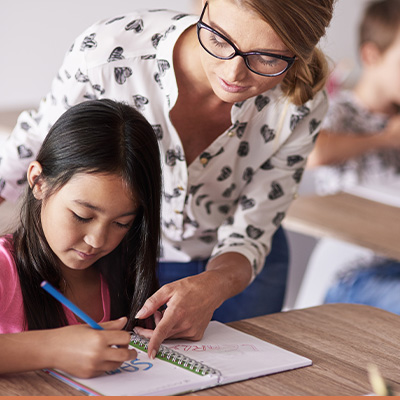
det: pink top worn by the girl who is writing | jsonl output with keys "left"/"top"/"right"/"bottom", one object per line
{"left": 0, "top": 236, "right": 110, "bottom": 333}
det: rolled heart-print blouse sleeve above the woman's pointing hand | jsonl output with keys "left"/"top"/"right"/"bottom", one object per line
{"left": 212, "top": 92, "right": 327, "bottom": 279}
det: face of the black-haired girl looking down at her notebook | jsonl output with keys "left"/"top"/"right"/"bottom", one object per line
{"left": 30, "top": 165, "right": 137, "bottom": 270}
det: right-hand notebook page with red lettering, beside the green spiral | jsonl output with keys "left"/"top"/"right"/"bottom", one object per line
{"left": 164, "top": 321, "right": 312, "bottom": 384}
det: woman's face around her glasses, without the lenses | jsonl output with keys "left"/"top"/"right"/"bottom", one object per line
{"left": 200, "top": 0, "right": 294, "bottom": 103}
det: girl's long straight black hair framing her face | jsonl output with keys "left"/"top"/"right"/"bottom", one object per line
{"left": 13, "top": 100, "right": 161, "bottom": 330}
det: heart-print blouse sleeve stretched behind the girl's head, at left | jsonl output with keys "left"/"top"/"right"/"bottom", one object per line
{"left": 0, "top": 27, "right": 96, "bottom": 201}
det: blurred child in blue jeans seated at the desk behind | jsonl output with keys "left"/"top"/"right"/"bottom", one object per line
{"left": 308, "top": 0, "right": 400, "bottom": 314}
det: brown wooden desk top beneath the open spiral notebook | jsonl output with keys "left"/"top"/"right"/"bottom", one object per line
{"left": 0, "top": 304, "right": 400, "bottom": 396}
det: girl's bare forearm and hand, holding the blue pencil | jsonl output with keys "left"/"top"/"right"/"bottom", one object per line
{"left": 0, "top": 318, "right": 137, "bottom": 378}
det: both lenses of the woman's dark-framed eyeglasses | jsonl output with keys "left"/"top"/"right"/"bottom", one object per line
{"left": 199, "top": 26, "right": 288, "bottom": 75}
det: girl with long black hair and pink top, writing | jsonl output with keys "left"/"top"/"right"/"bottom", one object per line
{"left": 0, "top": 100, "right": 161, "bottom": 377}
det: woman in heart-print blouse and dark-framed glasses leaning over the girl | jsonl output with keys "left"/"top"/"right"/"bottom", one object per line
{"left": 0, "top": 0, "right": 334, "bottom": 351}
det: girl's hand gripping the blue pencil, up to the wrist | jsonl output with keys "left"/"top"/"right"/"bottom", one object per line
{"left": 47, "top": 317, "right": 137, "bottom": 378}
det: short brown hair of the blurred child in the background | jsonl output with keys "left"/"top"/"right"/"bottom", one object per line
{"left": 359, "top": 0, "right": 400, "bottom": 53}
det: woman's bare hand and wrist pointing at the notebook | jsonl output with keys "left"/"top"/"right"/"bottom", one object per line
{"left": 135, "top": 253, "right": 251, "bottom": 358}
